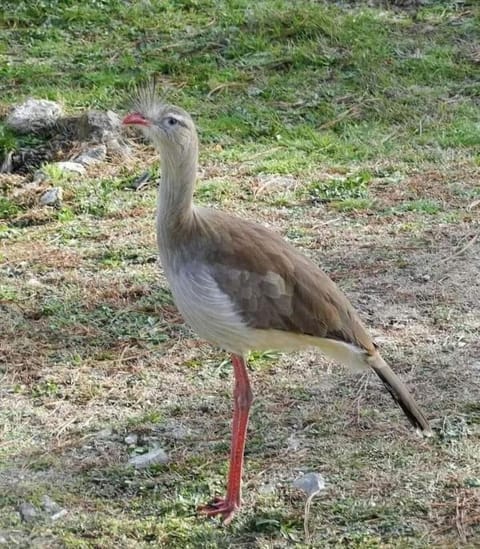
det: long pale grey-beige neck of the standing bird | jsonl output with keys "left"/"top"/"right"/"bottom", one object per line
{"left": 157, "top": 139, "right": 198, "bottom": 247}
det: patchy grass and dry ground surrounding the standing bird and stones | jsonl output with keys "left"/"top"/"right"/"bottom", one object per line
{"left": 0, "top": 0, "right": 480, "bottom": 549}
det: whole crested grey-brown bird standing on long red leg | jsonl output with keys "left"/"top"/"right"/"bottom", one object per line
{"left": 123, "top": 92, "right": 432, "bottom": 524}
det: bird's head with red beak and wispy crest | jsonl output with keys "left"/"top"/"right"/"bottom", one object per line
{"left": 123, "top": 90, "right": 197, "bottom": 156}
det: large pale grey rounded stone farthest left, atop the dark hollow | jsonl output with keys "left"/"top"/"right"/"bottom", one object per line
{"left": 6, "top": 99, "right": 62, "bottom": 133}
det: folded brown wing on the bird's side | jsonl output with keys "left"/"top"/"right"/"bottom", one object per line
{"left": 190, "top": 210, "right": 375, "bottom": 353}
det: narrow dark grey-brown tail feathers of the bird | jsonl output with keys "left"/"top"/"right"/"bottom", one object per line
{"left": 368, "top": 355, "right": 432, "bottom": 436}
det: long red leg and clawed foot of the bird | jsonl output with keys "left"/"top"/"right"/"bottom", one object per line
{"left": 199, "top": 355, "right": 253, "bottom": 524}
